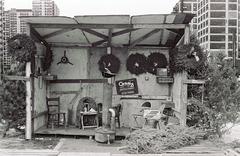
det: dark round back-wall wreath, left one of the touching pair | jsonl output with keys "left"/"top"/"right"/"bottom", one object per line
{"left": 127, "top": 53, "right": 147, "bottom": 75}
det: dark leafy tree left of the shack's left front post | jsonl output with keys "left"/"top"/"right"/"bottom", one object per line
{"left": 0, "top": 63, "right": 26, "bottom": 131}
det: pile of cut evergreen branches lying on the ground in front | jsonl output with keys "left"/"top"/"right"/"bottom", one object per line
{"left": 123, "top": 125, "right": 205, "bottom": 154}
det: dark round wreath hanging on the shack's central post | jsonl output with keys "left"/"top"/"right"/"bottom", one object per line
{"left": 98, "top": 54, "right": 120, "bottom": 78}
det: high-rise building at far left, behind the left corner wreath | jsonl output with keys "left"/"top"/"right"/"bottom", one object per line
{"left": 3, "top": 9, "right": 32, "bottom": 71}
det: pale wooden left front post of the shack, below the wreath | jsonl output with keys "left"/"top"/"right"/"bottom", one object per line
{"left": 25, "top": 62, "right": 32, "bottom": 140}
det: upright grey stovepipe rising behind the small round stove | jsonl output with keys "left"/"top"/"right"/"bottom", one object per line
{"left": 102, "top": 83, "right": 113, "bottom": 127}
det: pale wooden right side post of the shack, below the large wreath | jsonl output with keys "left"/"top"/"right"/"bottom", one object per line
{"left": 172, "top": 72, "right": 187, "bottom": 126}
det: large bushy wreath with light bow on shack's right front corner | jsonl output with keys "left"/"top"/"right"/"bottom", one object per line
{"left": 170, "top": 44, "right": 205, "bottom": 73}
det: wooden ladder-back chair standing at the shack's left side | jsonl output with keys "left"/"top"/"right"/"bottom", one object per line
{"left": 46, "top": 97, "right": 66, "bottom": 128}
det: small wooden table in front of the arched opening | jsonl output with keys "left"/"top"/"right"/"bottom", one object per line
{"left": 80, "top": 112, "right": 99, "bottom": 130}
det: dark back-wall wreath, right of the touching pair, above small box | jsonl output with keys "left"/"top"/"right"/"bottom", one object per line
{"left": 147, "top": 53, "right": 168, "bottom": 75}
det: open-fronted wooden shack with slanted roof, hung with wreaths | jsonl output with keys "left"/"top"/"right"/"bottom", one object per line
{"left": 22, "top": 13, "right": 193, "bottom": 139}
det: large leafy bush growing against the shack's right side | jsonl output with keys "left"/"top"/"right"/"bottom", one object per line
{"left": 188, "top": 53, "right": 240, "bottom": 137}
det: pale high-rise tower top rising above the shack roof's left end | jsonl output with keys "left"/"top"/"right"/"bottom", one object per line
{"left": 32, "top": 0, "right": 59, "bottom": 16}
